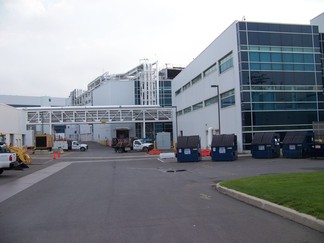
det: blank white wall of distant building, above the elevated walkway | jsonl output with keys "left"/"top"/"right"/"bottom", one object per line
{"left": 93, "top": 79, "right": 135, "bottom": 106}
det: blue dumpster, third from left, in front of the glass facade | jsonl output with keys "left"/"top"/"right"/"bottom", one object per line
{"left": 251, "top": 132, "right": 280, "bottom": 158}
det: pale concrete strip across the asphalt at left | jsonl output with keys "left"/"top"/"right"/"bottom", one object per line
{"left": 0, "top": 162, "right": 72, "bottom": 203}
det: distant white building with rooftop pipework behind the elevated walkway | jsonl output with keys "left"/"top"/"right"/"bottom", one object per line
{"left": 65, "top": 60, "right": 182, "bottom": 142}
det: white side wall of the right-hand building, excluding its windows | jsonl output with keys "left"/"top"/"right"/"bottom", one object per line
{"left": 172, "top": 22, "right": 242, "bottom": 151}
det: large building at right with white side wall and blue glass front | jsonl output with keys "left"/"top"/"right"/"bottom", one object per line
{"left": 172, "top": 14, "right": 324, "bottom": 151}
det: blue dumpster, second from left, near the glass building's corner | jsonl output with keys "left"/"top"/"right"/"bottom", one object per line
{"left": 211, "top": 134, "right": 237, "bottom": 161}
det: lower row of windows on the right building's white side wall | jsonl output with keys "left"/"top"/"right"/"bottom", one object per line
{"left": 177, "top": 89, "right": 235, "bottom": 116}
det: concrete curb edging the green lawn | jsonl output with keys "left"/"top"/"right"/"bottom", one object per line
{"left": 213, "top": 183, "right": 324, "bottom": 233}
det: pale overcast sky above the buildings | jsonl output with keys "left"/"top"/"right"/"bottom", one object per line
{"left": 0, "top": 0, "right": 324, "bottom": 97}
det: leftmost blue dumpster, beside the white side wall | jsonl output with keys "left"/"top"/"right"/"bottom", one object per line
{"left": 177, "top": 135, "right": 201, "bottom": 162}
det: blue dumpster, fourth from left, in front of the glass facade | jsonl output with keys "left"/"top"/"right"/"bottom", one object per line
{"left": 282, "top": 131, "right": 314, "bottom": 158}
